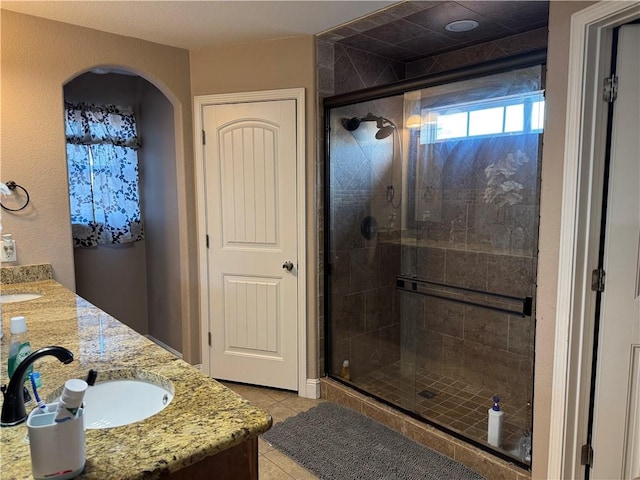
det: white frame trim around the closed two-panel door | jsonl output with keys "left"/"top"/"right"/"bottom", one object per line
{"left": 193, "top": 88, "right": 308, "bottom": 398}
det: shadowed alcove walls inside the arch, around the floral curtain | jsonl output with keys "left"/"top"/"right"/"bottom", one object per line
{"left": 63, "top": 66, "right": 184, "bottom": 356}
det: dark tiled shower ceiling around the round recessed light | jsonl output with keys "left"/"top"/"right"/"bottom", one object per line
{"left": 321, "top": 0, "right": 549, "bottom": 62}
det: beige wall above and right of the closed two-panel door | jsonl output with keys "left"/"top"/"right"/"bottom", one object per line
{"left": 190, "top": 36, "right": 318, "bottom": 378}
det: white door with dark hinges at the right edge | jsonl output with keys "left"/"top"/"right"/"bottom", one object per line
{"left": 591, "top": 25, "right": 640, "bottom": 480}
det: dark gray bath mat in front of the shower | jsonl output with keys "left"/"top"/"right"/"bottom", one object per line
{"left": 262, "top": 403, "right": 484, "bottom": 480}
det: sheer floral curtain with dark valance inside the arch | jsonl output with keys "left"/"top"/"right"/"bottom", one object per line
{"left": 65, "top": 102, "right": 144, "bottom": 247}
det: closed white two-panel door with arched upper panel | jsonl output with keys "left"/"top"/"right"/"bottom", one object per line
{"left": 203, "top": 100, "right": 304, "bottom": 390}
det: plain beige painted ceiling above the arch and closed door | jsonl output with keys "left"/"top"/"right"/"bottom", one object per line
{"left": 1, "top": 0, "right": 395, "bottom": 49}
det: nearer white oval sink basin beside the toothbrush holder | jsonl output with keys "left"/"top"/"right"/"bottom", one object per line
{"left": 56, "top": 371, "right": 174, "bottom": 429}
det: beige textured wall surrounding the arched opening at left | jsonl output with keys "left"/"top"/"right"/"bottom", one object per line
{"left": 0, "top": 10, "right": 199, "bottom": 361}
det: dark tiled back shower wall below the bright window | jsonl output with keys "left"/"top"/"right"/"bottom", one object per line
{"left": 400, "top": 134, "right": 539, "bottom": 408}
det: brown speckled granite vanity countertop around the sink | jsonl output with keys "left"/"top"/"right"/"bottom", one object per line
{"left": 0, "top": 280, "right": 272, "bottom": 480}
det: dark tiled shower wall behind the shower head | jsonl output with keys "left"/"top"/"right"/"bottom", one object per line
{"left": 329, "top": 98, "right": 402, "bottom": 378}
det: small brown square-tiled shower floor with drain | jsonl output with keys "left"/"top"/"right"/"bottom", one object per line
{"left": 351, "top": 362, "right": 531, "bottom": 463}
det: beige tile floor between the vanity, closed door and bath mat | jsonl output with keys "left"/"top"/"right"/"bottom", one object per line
{"left": 220, "top": 381, "right": 324, "bottom": 480}
